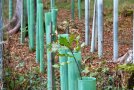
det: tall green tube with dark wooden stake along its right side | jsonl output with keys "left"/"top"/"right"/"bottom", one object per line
{"left": 45, "top": 12, "right": 55, "bottom": 90}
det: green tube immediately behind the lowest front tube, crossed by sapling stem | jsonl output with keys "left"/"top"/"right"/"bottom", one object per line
{"left": 68, "top": 52, "right": 81, "bottom": 90}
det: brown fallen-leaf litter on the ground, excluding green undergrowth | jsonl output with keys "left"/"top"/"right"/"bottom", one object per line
{"left": 4, "top": 9, "right": 132, "bottom": 89}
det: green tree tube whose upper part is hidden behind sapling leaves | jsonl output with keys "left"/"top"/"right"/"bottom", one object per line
{"left": 58, "top": 34, "right": 69, "bottom": 90}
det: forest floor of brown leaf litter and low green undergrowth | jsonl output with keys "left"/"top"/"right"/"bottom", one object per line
{"left": 4, "top": 1, "right": 132, "bottom": 90}
